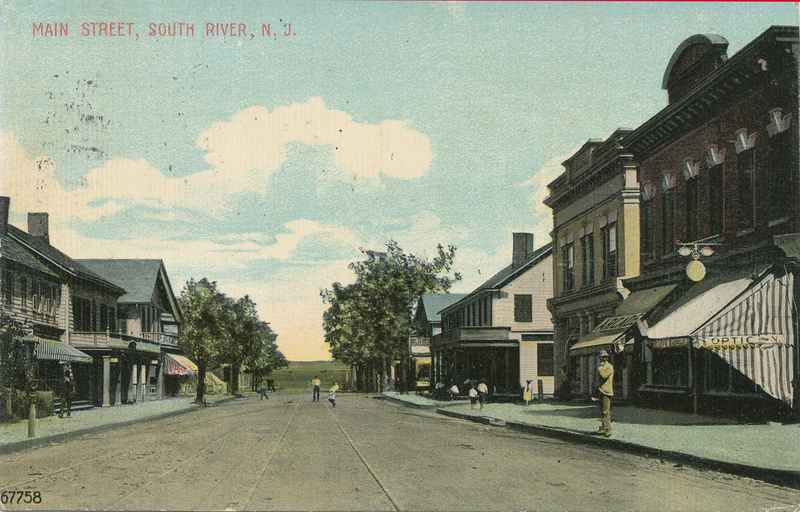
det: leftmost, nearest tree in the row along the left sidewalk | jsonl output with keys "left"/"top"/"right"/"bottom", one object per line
{"left": 178, "top": 278, "right": 231, "bottom": 403}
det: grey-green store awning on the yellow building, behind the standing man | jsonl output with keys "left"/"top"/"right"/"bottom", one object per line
{"left": 570, "top": 285, "right": 676, "bottom": 355}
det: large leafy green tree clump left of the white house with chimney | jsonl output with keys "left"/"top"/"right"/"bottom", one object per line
{"left": 320, "top": 241, "right": 461, "bottom": 389}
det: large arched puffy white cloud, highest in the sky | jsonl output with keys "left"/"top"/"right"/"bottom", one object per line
{"left": 197, "top": 98, "right": 431, "bottom": 183}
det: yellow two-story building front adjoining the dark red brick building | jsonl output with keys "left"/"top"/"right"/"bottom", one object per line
{"left": 545, "top": 129, "right": 639, "bottom": 397}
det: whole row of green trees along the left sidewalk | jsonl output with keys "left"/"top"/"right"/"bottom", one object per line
{"left": 178, "top": 278, "right": 289, "bottom": 403}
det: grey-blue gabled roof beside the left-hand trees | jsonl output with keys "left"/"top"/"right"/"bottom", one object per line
{"left": 80, "top": 259, "right": 181, "bottom": 320}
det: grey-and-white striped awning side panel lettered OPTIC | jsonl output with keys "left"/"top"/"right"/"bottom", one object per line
{"left": 692, "top": 273, "right": 795, "bottom": 404}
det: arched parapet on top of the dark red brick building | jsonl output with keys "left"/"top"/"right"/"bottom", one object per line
{"left": 661, "top": 34, "right": 728, "bottom": 103}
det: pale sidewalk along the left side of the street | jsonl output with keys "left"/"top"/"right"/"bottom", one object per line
{"left": 0, "top": 395, "right": 230, "bottom": 454}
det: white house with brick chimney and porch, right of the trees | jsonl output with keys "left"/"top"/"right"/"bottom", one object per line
{"left": 431, "top": 233, "right": 554, "bottom": 398}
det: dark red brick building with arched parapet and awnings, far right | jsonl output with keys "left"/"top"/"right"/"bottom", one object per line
{"left": 623, "top": 27, "right": 800, "bottom": 416}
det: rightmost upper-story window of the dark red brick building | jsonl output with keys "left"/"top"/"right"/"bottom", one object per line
{"left": 767, "top": 108, "right": 796, "bottom": 222}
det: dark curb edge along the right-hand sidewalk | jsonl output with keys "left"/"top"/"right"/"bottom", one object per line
{"left": 436, "top": 409, "right": 800, "bottom": 489}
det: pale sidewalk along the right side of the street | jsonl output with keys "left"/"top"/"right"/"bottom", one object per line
{"left": 383, "top": 393, "right": 800, "bottom": 488}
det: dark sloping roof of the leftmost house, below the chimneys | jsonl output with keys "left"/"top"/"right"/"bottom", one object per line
{"left": 0, "top": 224, "right": 125, "bottom": 295}
